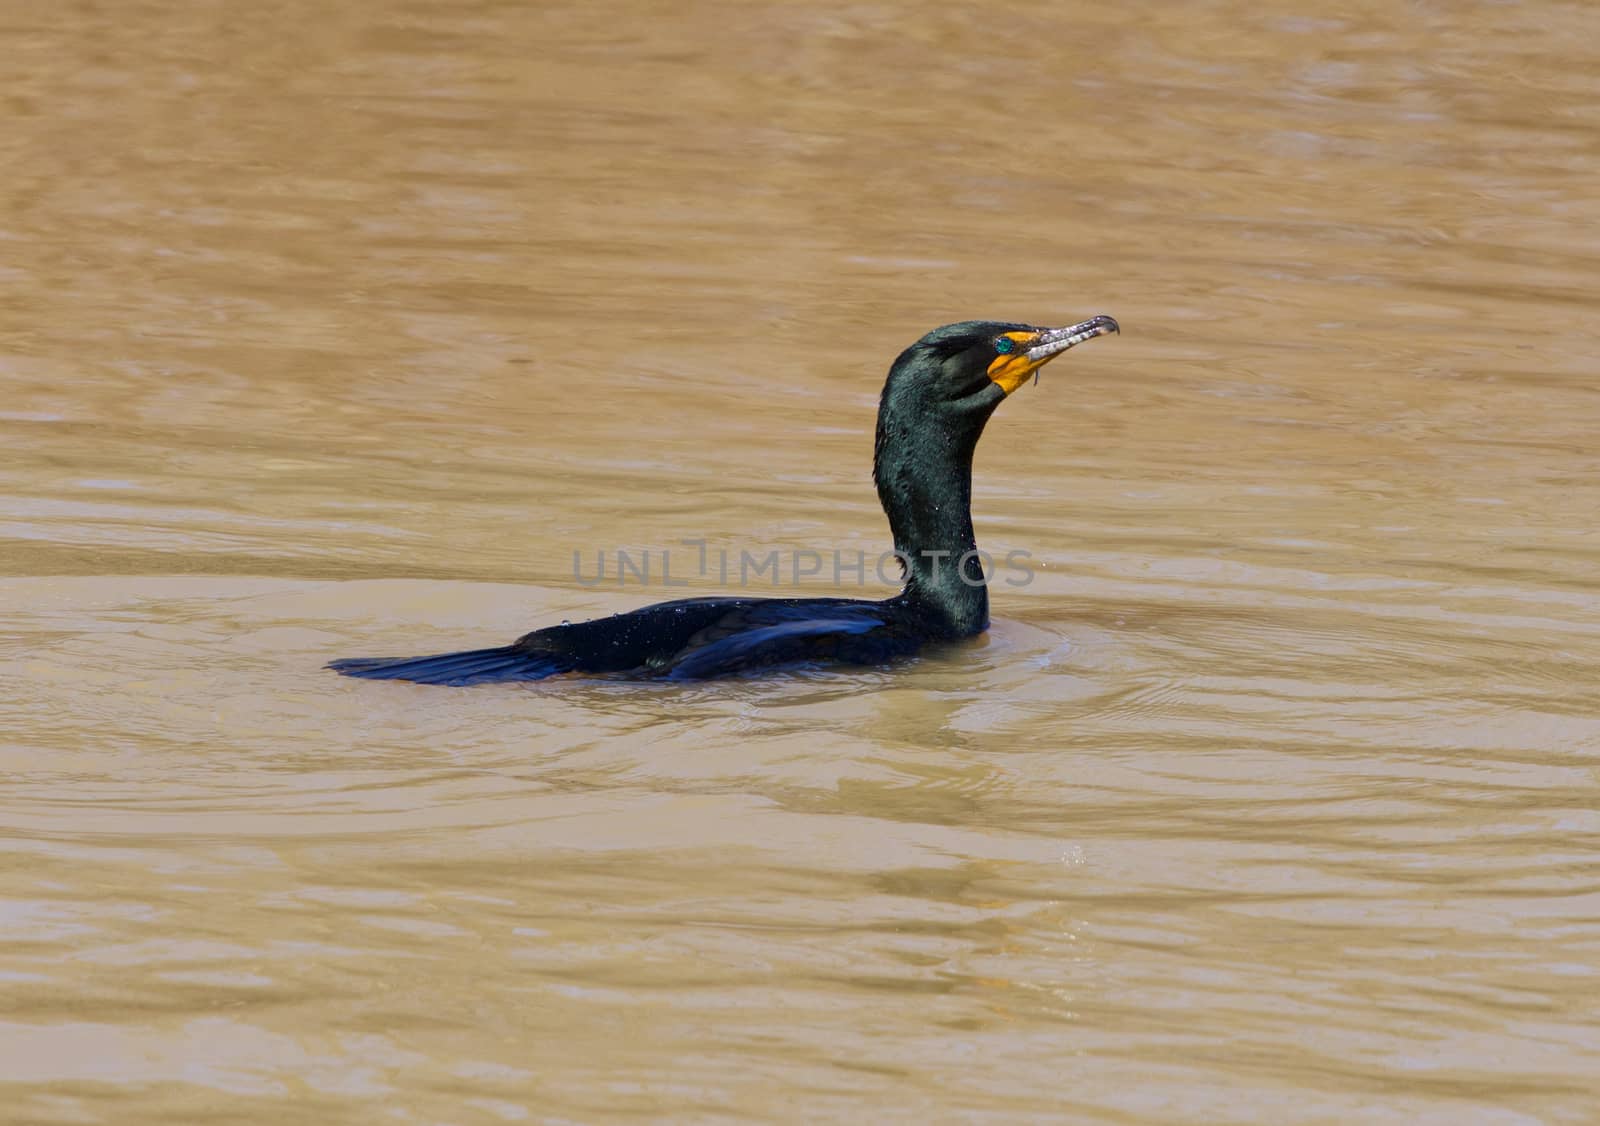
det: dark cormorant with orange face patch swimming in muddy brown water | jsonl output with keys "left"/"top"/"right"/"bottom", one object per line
{"left": 328, "top": 317, "right": 1120, "bottom": 685}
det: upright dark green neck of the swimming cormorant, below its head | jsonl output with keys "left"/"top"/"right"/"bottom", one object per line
{"left": 874, "top": 399, "right": 989, "bottom": 638}
